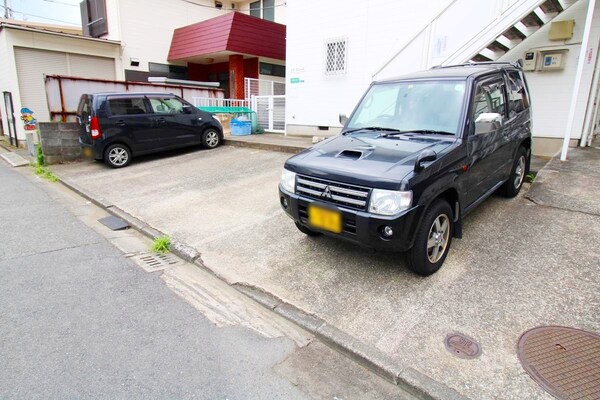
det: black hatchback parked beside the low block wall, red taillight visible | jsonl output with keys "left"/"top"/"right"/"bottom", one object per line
{"left": 77, "top": 93, "right": 223, "bottom": 168}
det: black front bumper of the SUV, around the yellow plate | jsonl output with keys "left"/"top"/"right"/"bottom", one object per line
{"left": 279, "top": 187, "right": 421, "bottom": 251}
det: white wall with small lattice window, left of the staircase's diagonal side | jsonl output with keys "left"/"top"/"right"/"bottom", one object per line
{"left": 286, "top": 0, "right": 448, "bottom": 135}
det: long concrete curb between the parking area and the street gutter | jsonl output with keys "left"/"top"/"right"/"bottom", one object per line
{"left": 59, "top": 173, "right": 468, "bottom": 400}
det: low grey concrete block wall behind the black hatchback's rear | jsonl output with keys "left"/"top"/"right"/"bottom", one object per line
{"left": 39, "top": 122, "right": 81, "bottom": 164}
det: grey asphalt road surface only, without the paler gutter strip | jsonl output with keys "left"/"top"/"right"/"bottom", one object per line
{"left": 0, "top": 164, "right": 314, "bottom": 399}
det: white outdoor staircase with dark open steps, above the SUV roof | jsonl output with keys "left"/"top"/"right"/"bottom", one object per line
{"left": 443, "top": 0, "right": 577, "bottom": 65}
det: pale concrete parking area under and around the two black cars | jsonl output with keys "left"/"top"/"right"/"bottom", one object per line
{"left": 53, "top": 147, "right": 600, "bottom": 399}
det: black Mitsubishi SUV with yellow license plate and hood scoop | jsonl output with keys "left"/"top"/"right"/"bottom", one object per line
{"left": 279, "top": 63, "right": 531, "bottom": 275}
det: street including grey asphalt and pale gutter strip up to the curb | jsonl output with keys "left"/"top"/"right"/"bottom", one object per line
{"left": 0, "top": 157, "right": 412, "bottom": 400}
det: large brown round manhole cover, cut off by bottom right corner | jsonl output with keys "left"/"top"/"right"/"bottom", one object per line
{"left": 517, "top": 326, "right": 600, "bottom": 400}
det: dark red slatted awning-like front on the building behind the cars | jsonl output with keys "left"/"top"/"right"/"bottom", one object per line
{"left": 168, "top": 12, "right": 286, "bottom": 61}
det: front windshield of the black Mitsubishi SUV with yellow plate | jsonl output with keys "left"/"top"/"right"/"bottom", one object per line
{"left": 345, "top": 80, "right": 466, "bottom": 135}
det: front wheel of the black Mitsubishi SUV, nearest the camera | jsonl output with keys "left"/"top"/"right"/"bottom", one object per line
{"left": 406, "top": 199, "right": 454, "bottom": 276}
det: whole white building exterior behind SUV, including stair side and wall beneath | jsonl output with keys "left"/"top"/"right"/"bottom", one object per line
{"left": 286, "top": 0, "right": 600, "bottom": 155}
